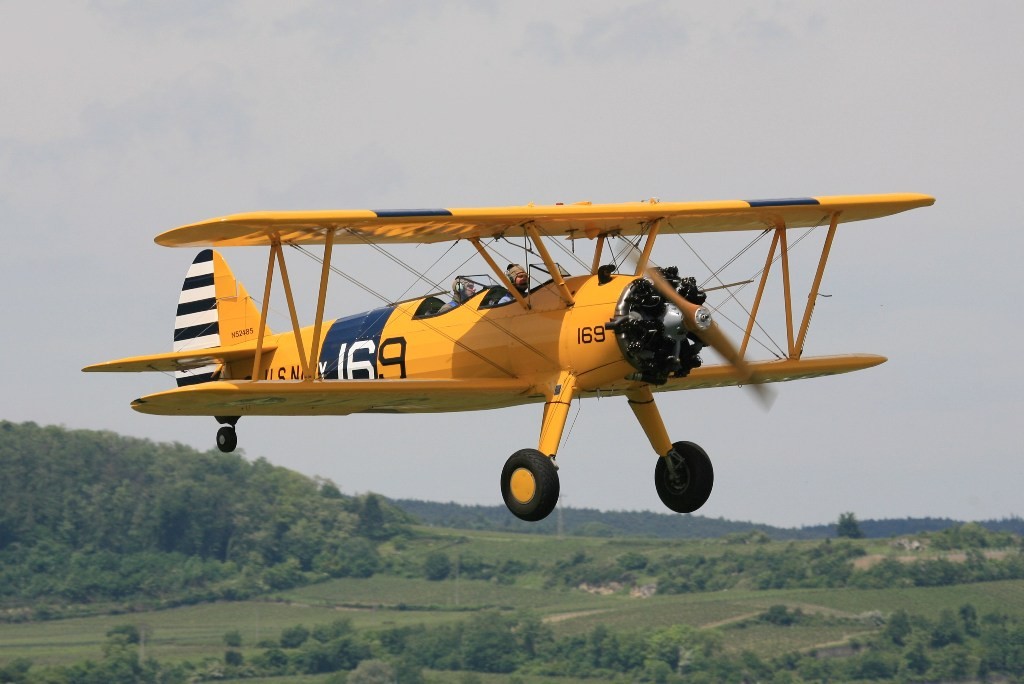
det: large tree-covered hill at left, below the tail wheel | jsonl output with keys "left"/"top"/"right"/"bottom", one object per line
{"left": 0, "top": 421, "right": 411, "bottom": 602}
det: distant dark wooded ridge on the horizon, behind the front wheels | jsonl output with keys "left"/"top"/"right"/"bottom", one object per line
{"left": 391, "top": 499, "right": 1024, "bottom": 540}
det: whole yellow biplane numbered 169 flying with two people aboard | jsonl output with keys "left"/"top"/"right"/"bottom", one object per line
{"left": 84, "top": 194, "right": 934, "bottom": 520}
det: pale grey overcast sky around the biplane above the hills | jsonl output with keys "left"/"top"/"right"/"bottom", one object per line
{"left": 0, "top": 0, "right": 1024, "bottom": 526}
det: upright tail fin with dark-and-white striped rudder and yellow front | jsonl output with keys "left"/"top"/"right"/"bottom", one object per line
{"left": 173, "top": 250, "right": 270, "bottom": 387}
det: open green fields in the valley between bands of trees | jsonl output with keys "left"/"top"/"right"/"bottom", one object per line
{"left": 0, "top": 528, "right": 1024, "bottom": 681}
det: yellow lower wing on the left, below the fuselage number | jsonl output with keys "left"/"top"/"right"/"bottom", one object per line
{"left": 131, "top": 379, "right": 544, "bottom": 416}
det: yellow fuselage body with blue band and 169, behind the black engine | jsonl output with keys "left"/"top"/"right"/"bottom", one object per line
{"left": 234, "top": 275, "right": 636, "bottom": 391}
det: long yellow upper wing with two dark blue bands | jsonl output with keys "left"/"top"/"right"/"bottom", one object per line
{"left": 157, "top": 194, "right": 935, "bottom": 247}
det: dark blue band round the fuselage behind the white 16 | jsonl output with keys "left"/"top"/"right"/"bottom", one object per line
{"left": 318, "top": 306, "right": 394, "bottom": 380}
